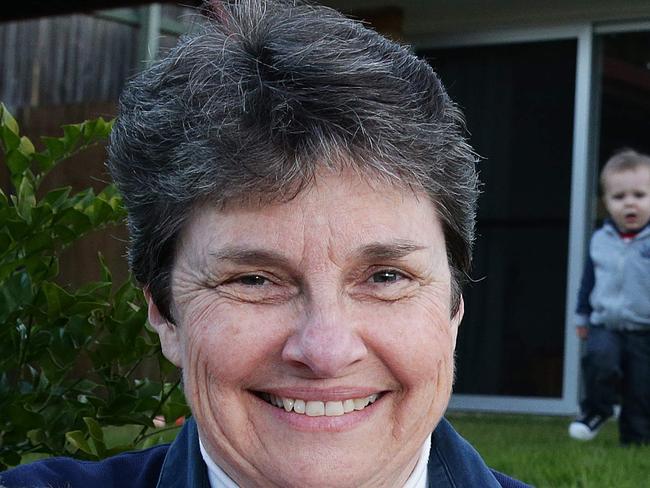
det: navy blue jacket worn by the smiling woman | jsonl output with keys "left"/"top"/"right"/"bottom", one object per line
{"left": 0, "top": 419, "right": 528, "bottom": 488}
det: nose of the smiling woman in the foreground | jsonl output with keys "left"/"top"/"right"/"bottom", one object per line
{"left": 282, "top": 301, "right": 368, "bottom": 378}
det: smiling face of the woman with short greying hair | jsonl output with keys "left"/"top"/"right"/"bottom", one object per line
{"left": 150, "top": 170, "right": 462, "bottom": 488}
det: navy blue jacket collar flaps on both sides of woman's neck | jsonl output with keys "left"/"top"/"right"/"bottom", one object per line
{"left": 156, "top": 418, "right": 500, "bottom": 488}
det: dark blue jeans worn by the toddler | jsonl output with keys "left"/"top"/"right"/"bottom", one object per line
{"left": 582, "top": 326, "right": 650, "bottom": 444}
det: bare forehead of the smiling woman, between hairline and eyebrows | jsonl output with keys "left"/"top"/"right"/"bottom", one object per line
{"left": 182, "top": 174, "right": 444, "bottom": 264}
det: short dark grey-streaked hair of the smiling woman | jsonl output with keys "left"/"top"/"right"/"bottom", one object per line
{"left": 108, "top": 0, "right": 478, "bottom": 322}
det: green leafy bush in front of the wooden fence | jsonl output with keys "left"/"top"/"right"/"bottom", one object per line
{"left": 0, "top": 104, "right": 188, "bottom": 469}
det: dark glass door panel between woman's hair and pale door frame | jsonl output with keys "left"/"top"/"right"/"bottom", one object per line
{"left": 420, "top": 40, "right": 576, "bottom": 397}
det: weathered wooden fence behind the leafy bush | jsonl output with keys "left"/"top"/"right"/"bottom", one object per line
{"left": 0, "top": 5, "right": 194, "bottom": 284}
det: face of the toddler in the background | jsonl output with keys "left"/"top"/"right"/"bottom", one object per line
{"left": 604, "top": 167, "right": 650, "bottom": 232}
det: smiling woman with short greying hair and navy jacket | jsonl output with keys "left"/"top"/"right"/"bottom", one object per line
{"left": 2, "top": 0, "right": 523, "bottom": 488}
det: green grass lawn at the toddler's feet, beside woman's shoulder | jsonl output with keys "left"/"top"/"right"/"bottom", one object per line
{"left": 447, "top": 413, "right": 650, "bottom": 488}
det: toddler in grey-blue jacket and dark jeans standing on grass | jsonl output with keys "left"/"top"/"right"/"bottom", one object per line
{"left": 569, "top": 150, "right": 650, "bottom": 445}
